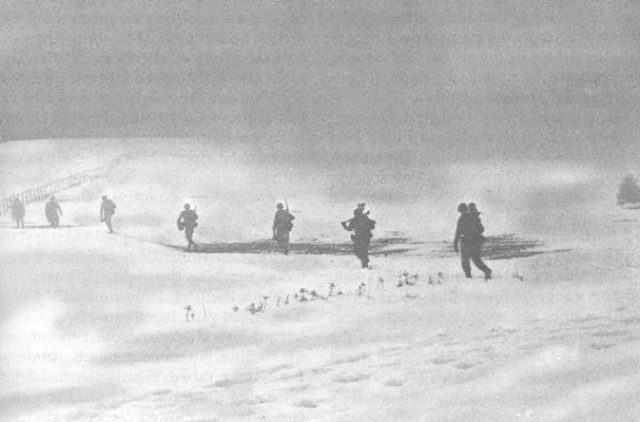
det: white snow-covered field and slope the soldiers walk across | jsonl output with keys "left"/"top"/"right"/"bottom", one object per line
{"left": 0, "top": 140, "right": 640, "bottom": 421}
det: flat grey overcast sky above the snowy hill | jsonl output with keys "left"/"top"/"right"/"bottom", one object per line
{"left": 0, "top": 0, "right": 640, "bottom": 166}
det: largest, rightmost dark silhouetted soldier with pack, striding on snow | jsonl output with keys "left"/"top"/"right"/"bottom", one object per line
{"left": 453, "top": 203, "right": 491, "bottom": 280}
